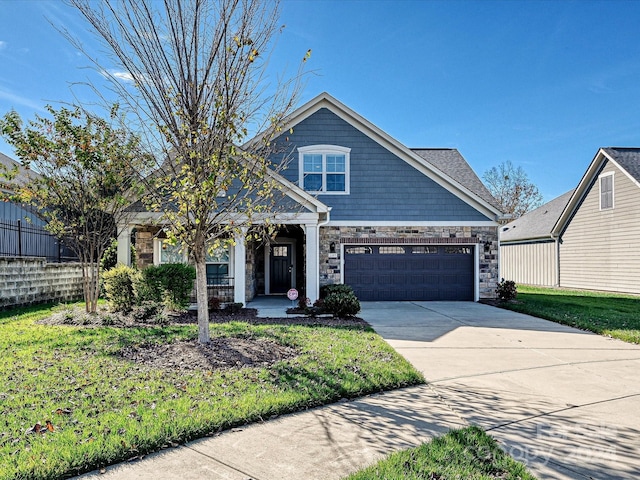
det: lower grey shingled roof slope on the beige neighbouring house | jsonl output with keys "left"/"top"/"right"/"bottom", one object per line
{"left": 500, "top": 190, "right": 574, "bottom": 243}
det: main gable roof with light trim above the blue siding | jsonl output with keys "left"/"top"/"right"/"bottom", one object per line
{"left": 246, "top": 92, "right": 503, "bottom": 220}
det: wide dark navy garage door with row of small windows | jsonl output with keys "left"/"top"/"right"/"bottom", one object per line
{"left": 344, "top": 245, "right": 474, "bottom": 300}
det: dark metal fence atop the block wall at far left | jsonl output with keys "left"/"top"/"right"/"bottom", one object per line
{"left": 0, "top": 220, "right": 78, "bottom": 263}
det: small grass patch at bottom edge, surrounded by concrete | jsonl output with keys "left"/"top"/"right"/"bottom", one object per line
{"left": 347, "top": 427, "right": 535, "bottom": 480}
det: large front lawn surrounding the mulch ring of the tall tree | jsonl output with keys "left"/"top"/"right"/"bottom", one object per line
{"left": 0, "top": 307, "right": 424, "bottom": 479}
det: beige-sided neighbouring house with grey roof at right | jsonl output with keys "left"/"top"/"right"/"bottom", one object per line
{"left": 500, "top": 147, "right": 640, "bottom": 294}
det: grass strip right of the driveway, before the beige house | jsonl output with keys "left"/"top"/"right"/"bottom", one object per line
{"left": 502, "top": 286, "right": 640, "bottom": 343}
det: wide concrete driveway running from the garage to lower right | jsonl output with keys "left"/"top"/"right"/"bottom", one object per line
{"left": 361, "top": 302, "right": 640, "bottom": 479}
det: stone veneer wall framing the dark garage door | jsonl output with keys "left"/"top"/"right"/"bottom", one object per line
{"left": 320, "top": 227, "right": 499, "bottom": 298}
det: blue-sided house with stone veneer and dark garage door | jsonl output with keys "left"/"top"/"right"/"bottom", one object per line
{"left": 118, "top": 93, "right": 502, "bottom": 302}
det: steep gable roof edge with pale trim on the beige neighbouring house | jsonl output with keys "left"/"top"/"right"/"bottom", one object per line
{"left": 551, "top": 147, "right": 640, "bottom": 236}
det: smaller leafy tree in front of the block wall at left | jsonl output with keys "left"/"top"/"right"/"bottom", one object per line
{"left": 0, "top": 106, "right": 146, "bottom": 313}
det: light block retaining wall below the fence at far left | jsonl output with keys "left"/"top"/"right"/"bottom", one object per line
{"left": 0, "top": 257, "right": 83, "bottom": 309}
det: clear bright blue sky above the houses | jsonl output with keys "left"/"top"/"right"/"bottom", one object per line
{"left": 0, "top": 0, "right": 640, "bottom": 200}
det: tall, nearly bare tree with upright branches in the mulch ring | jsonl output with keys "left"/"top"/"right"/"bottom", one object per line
{"left": 67, "top": 0, "right": 310, "bottom": 343}
